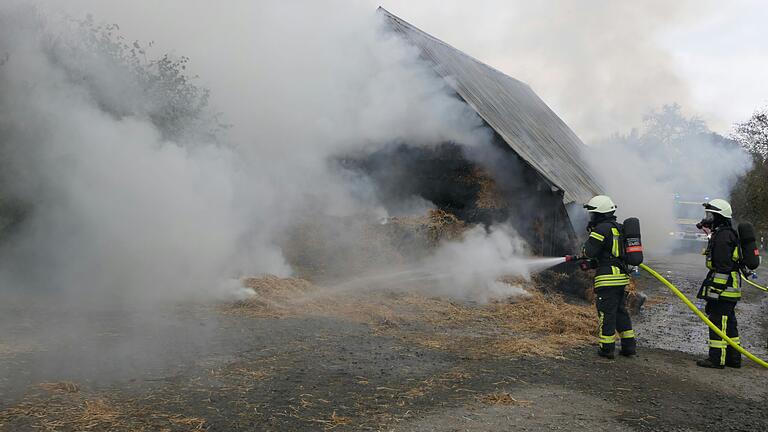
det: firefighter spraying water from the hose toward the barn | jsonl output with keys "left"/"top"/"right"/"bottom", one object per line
{"left": 582, "top": 195, "right": 636, "bottom": 359}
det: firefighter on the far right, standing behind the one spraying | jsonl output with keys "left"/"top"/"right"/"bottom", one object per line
{"left": 696, "top": 199, "right": 741, "bottom": 369}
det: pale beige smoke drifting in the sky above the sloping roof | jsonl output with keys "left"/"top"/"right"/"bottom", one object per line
{"left": 370, "top": 0, "right": 719, "bottom": 142}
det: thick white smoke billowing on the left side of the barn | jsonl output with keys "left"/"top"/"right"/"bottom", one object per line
{"left": 0, "top": 2, "right": 510, "bottom": 299}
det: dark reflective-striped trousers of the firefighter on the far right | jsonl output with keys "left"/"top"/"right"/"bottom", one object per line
{"left": 704, "top": 300, "right": 741, "bottom": 365}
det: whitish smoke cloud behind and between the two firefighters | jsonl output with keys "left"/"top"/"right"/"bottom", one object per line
{"left": 587, "top": 106, "right": 752, "bottom": 254}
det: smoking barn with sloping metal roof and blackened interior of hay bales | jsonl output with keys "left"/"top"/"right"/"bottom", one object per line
{"left": 345, "top": 8, "right": 601, "bottom": 255}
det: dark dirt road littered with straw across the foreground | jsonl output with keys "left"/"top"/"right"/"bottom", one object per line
{"left": 0, "top": 256, "right": 768, "bottom": 431}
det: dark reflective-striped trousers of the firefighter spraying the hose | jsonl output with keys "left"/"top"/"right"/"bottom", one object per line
{"left": 595, "top": 285, "right": 635, "bottom": 354}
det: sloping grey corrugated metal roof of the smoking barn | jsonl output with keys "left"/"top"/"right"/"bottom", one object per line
{"left": 379, "top": 8, "right": 602, "bottom": 203}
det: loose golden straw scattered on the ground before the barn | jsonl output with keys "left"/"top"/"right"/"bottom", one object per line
{"left": 231, "top": 276, "right": 596, "bottom": 357}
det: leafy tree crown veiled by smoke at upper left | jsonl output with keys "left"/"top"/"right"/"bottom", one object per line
{"left": 43, "top": 15, "right": 227, "bottom": 144}
